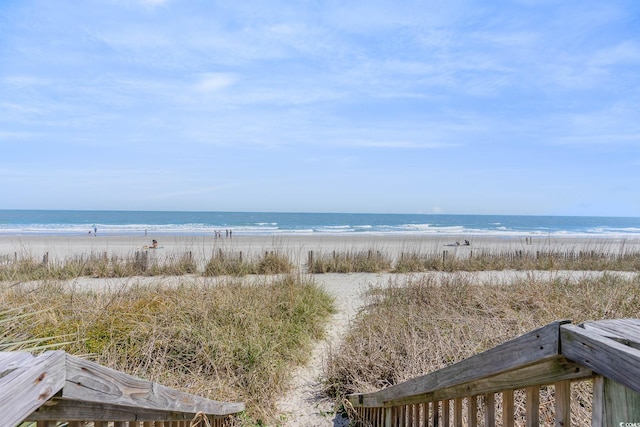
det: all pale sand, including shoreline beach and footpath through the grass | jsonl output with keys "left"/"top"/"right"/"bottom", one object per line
{"left": 0, "top": 233, "right": 640, "bottom": 427}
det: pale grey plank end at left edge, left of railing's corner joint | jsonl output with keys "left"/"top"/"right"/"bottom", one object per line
{"left": 0, "top": 351, "right": 65, "bottom": 426}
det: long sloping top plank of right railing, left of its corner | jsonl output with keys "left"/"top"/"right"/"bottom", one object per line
{"left": 348, "top": 321, "right": 566, "bottom": 406}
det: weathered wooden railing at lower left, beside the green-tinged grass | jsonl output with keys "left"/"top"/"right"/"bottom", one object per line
{"left": 0, "top": 351, "right": 244, "bottom": 427}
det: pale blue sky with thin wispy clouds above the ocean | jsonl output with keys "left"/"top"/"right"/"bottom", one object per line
{"left": 0, "top": 0, "right": 640, "bottom": 216}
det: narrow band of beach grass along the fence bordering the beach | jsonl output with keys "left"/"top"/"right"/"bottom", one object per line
{"left": 0, "top": 242, "right": 640, "bottom": 281}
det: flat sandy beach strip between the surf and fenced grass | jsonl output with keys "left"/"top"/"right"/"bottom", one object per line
{"left": 0, "top": 233, "right": 640, "bottom": 265}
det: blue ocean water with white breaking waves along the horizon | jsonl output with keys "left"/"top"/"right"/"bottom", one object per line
{"left": 0, "top": 210, "right": 640, "bottom": 238}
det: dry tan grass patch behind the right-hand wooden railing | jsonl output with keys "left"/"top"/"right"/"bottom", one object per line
{"left": 326, "top": 274, "right": 640, "bottom": 425}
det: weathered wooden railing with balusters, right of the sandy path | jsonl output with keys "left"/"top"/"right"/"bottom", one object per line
{"left": 348, "top": 319, "right": 640, "bottom": 427}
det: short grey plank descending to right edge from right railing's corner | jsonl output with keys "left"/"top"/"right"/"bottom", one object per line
{"left": 561, "top": 325, "right": 640, "bottom": 392}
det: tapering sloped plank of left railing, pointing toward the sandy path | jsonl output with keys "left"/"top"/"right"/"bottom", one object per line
{"left": 62, "top": 355, "right": 245, "bottom": 415}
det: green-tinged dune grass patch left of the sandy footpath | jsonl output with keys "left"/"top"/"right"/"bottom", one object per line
{"left": 0, "top": 275, "right": 334, "bottom": 425}
